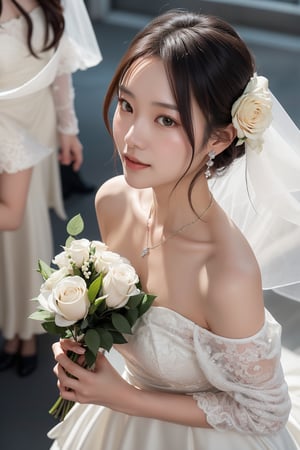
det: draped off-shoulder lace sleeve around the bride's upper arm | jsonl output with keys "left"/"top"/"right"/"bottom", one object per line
{"left": 193, "top": 311, "right": 291, "bottom": 434}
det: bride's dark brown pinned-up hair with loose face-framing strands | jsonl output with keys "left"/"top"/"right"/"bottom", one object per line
{"left": 103, "top": 9, "right": 255, "bottom": 206}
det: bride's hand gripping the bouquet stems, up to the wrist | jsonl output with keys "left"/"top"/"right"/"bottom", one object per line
{"left": 52, "top": 339, "right": 137, "bottom": 412}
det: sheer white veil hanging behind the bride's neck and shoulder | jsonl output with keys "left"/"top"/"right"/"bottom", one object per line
{"left": 210, "top": 92, "right": 300, "bottom": 301}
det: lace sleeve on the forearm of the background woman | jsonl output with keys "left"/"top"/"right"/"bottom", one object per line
{"left": 52, "top": 74, "right": 79, "bottom": 135}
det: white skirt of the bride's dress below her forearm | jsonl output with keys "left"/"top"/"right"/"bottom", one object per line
{"left": 48, "top": 350, "right": 300, "bottom": 450}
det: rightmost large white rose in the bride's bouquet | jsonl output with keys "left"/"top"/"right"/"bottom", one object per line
{"left": 103, "top": 261, "right": 140, "bottom": 308}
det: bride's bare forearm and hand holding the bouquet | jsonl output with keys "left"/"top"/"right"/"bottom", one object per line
{"left": 53, "top": 340, "right": 210, "bottom": 428}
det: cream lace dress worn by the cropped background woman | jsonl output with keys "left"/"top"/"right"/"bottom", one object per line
{"left": 0, "top": 7, "right": 78, "bottom": 339}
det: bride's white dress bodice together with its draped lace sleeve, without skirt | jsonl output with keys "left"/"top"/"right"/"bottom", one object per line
{"left": 118, "top": 307, "right": 290, "bottom": 433}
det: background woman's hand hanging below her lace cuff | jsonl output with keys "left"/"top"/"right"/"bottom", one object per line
{"left": 58, "top": 133, "right": 83, "bottom": 172}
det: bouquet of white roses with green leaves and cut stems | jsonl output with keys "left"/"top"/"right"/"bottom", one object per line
{"left": 30, "top": 215, "right": 155, "bottom": 420}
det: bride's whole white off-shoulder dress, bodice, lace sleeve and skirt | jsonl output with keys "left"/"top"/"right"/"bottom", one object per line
{"left": 48, "top": 307, "right": 298, "bottom": 450}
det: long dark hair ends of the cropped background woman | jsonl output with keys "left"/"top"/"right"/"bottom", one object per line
{"left": 0, "top": 0, "right": 63, "bottom": 57}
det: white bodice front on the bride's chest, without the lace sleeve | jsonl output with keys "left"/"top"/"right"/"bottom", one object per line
{"left": 118, "top": 307, "right": 212, "bottom": 392}
